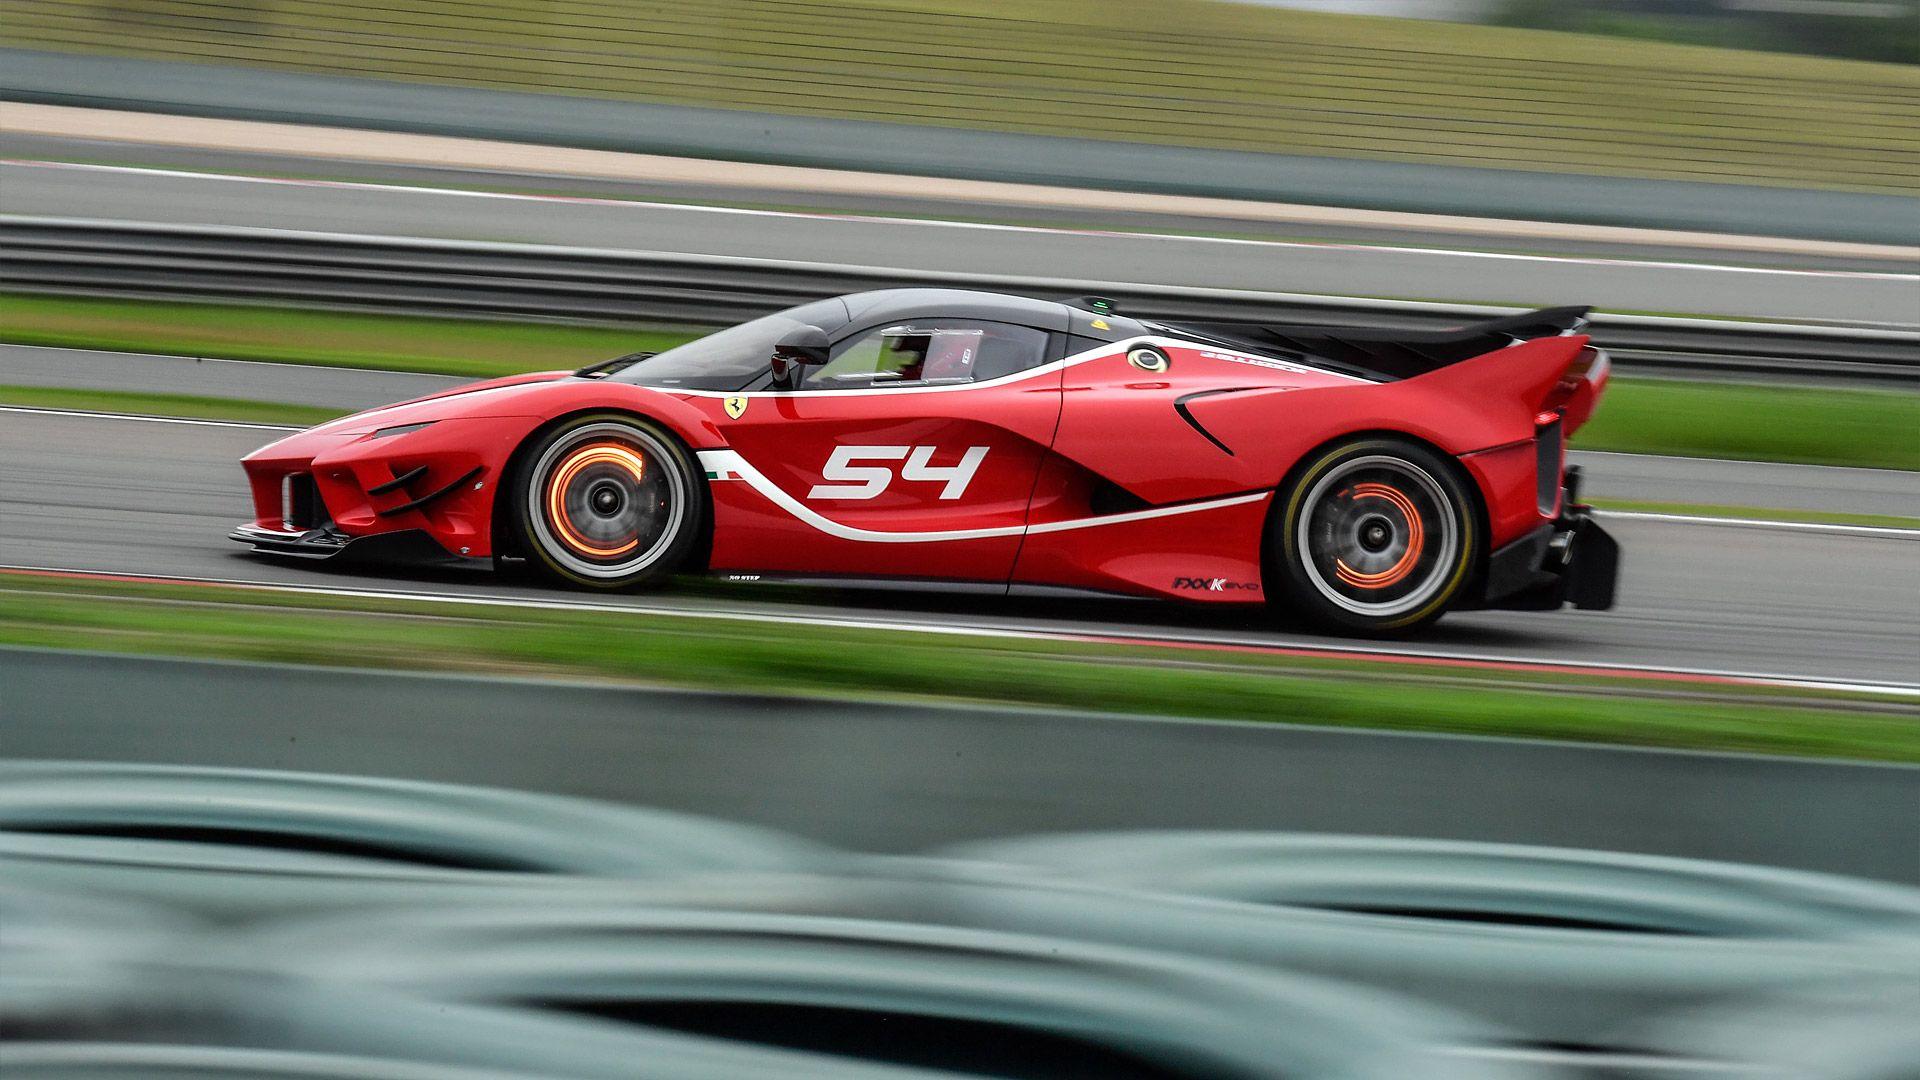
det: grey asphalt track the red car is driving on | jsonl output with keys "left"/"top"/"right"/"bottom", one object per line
{"left": 0, "top": 399, "right": 1920, "bottom": 684}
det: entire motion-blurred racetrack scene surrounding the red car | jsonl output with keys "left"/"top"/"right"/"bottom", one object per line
{"left": 0, "top": 0, "right": 1920, "bottom": 1080}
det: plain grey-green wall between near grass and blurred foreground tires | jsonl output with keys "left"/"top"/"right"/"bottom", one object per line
{"left": 0, "top": 648, "right": 1920, "bottom": 882}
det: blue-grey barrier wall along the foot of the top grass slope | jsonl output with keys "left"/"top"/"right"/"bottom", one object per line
{"left": 0, "top": 48, "right": 1920, "bottom": 244}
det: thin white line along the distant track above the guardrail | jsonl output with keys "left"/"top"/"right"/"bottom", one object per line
{"left": 0, "top": 160, "right": 1920, "bottom": 282}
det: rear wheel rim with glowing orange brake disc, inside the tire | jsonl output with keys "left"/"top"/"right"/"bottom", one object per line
{"left": 1296, "top": 455, "right": 1459, "bottom": 617}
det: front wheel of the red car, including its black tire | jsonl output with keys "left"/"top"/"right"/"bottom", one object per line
{"left": 505, "top": 413, "right": 707, "bottom": 588}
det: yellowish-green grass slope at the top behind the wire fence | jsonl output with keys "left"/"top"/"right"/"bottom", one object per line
{"left": 0, "top": 0, "right": 1920, "bottom": 194}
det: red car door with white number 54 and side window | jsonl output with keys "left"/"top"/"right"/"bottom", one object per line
{"left": 712, "top": 315, "right": 1064, "bottom": 584}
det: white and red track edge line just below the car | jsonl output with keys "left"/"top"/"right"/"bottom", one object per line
{"left": 0, "top": 563, "right": 1920, "bottom": 700}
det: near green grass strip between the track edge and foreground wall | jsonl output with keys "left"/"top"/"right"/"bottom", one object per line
{"left": 0, "top": 573, "right": 1920, "bottom": 761}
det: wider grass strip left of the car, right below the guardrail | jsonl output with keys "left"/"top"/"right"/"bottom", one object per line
{"left": 0, "top": 294, "right": 691, "bottom": 379}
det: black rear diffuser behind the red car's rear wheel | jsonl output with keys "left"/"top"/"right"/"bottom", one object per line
{"left": 1480, "top": 503, "right": 1620, "bottom": 611}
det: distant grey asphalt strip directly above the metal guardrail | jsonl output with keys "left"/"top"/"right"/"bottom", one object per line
{"left": 0, "top": 161, "right": 1920, "bottom": 325}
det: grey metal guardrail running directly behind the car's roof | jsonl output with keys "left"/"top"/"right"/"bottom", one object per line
{"left": 0, "top": 215, "right": 1920, "bottom": 384}
